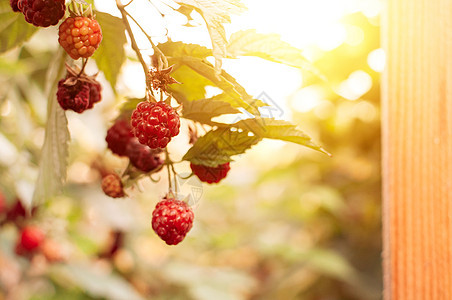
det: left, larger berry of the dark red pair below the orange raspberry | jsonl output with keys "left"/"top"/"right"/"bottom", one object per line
{"left": 57, "top": 78, "right": 91, "bottom": 113}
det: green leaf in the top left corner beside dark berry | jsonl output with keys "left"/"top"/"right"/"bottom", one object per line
{"left": 0, "top": 1, "right": 38, "bottom": 53}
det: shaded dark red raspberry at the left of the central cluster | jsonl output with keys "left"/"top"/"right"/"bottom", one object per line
{"left": 105, "top": 119, "right": 133, "bottom": 156}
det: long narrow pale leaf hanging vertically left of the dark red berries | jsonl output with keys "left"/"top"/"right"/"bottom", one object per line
{"left": 33, "top": 49, "right": 69, "bottom": 205}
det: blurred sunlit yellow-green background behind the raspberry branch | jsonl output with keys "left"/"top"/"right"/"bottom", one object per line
{"left": 0, "top": 1, "right": 382, "bottom": 300}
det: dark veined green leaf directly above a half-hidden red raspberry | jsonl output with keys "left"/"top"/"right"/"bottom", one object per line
{"left": 183, "top": 128, "right": 262, "bottom": 167}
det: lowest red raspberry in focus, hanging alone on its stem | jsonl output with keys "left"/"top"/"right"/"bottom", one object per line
{"left": 152, "top": 198, "right": 195, "bottom": 245}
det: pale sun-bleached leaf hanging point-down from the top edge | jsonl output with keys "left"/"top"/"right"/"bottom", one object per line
{"left": 175, "top": 0, "right": 246, "bottom": 74}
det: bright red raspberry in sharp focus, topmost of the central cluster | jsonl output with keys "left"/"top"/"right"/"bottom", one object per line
{"left": 131, "top": 102, "right": 180, "bottom": 149}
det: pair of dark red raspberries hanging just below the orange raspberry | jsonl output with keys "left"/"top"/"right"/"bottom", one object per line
{"left": 57, "top": 76, "right": 102, "bottom": 113}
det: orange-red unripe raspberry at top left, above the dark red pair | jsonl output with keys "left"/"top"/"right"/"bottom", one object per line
{"left": 58, "top": 17, "right": 102, "bottom": 59}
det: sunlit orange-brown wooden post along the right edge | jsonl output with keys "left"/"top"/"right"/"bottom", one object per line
{"left": 382, "top": 0, "right": 452, "bottom": 300}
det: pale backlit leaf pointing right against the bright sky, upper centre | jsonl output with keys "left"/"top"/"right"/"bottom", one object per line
{"left": 227, "top": 29, "right": 326, "bottom": 80}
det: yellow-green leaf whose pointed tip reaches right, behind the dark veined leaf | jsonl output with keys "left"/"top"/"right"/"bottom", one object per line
{"left": 217, "top": 118, "right": 331, "bottom": 156}
